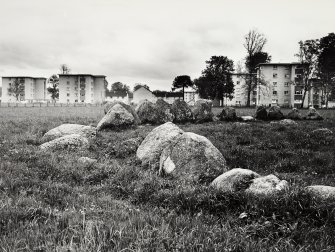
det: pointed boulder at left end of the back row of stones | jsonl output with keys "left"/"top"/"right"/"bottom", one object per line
{"left": 97, "top": 104, "right": 135, "bottom": 131}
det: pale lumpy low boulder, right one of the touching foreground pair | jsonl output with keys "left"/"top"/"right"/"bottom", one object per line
{"left": 245, "top": 174, "right": 288, "bottom": 196}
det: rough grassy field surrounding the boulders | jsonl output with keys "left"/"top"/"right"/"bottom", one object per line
{"left": 0, "top": 107, "right": 335, "bottom": 252}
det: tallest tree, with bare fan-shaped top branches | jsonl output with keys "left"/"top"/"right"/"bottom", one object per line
{"left": 243, "top": 30, "right": 271, "bottom": 107}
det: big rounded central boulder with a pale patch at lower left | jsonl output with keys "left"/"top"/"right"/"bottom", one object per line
{"left": 159, "top": 132, "right": 227, "bottom": 183}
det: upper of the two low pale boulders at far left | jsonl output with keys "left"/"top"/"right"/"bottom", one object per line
{"left": 42, "top": 123, "right": 96, "bottom": 141}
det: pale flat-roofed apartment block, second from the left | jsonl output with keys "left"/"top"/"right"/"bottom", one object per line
{"left": 59, "top": 74, "right": 107, "bottom": 103}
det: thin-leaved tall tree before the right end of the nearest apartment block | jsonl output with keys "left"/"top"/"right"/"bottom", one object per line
{"left": 296, "top": 39, "right": 319, "bottom": 108}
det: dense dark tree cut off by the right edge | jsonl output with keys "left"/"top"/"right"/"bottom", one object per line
{"left": 318, "top": 33, "right": 335, "bottom": 108}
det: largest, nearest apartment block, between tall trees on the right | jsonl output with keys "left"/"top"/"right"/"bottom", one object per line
{"left": 256, "top": 63, "right": 321, "bottom": 107}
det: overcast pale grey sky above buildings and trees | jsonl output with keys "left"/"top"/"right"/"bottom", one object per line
{"left": 0, "top": 0, "right": 335, "bottom": 90}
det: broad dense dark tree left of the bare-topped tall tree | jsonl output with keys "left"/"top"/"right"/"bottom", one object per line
{"left": 194, "top": 56, "right": 234, "bottom": 100}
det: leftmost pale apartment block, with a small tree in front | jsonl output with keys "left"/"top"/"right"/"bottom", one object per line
{"left": 1, "top": 76, "right": 48, "bottom": 102}
